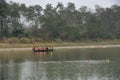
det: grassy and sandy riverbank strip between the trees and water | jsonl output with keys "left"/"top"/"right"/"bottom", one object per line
{"left": 0, "top": 39, "right": 120, "bottom": 51}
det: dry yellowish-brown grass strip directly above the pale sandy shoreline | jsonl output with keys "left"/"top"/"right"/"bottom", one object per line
{"left": 0, "top": 39, "right": 120, "bottom": 48}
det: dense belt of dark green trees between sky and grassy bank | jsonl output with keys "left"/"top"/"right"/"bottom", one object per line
{"left": 0, "top": 0, "right": 120, "bottom": 41}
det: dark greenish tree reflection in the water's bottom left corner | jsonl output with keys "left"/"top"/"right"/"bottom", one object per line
{"left": 0, "top": 59, "right": 19, "bottom": 80}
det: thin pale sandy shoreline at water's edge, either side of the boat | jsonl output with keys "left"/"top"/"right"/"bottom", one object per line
{"left": 0, "top": 45, "right": 120, "bottom": 51}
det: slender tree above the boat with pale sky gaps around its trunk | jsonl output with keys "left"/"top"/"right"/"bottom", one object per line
{"left": 26, "top": 5, "right": 42, "bottom": 37}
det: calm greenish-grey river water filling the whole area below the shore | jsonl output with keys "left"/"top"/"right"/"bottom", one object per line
{"left": 0, "top": 48, "right": 120, "bottom": 80}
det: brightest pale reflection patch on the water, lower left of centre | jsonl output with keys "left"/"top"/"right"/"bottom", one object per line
{"left": 18, "top": 60, "right": 46, "bottom": 80}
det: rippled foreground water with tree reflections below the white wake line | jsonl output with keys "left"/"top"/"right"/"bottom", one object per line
{"left": 0, "top": 59, "right": 120, "bottom": 80}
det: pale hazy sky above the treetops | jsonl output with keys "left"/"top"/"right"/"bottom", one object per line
{"left": 6, "top": 0, "right": 120, "bottom": 8}
